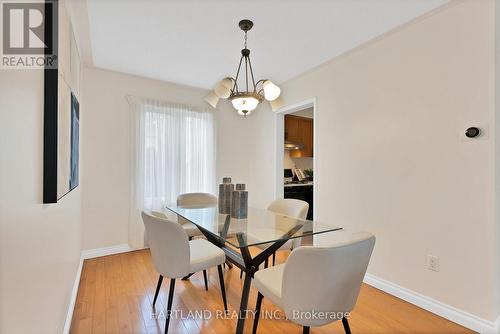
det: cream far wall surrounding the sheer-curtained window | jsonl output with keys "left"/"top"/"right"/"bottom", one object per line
{"left": 82, "top": 69, "right": 256, "bottom": 249}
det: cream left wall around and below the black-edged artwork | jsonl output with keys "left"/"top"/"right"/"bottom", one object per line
{"left": 0, "top": 70, "right": 81, "bottom": 334}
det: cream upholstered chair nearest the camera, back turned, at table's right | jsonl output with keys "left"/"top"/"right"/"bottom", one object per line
{"left": 253, "top": 231, "right": 375, "bottom": 334}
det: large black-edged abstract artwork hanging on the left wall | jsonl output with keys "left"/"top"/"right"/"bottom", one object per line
{"left": 43, "top": 1, "right": 81, "bottom": 203}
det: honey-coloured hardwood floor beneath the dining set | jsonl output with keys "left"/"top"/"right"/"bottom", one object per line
{"left": 70, "top": 250, "right": 473, "bottom": 334}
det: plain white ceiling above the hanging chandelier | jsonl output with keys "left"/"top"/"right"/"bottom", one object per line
{"left": 87, "top": 0, "right": 448, "bottom": 88}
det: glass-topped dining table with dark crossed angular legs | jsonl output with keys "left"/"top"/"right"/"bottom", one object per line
{"left": 167, "top": 205, "right": 342, "bottom": 334}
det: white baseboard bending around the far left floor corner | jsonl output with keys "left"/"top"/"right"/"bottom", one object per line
{"left": 63, "top": 244, "right": 134, "bottom": 334}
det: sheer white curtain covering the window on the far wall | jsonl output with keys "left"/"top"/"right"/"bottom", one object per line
{"left": 129, "top": 98, "right": 215, "bottom": 247}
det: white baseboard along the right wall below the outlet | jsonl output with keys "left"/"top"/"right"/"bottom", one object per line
{"left": 364, "top": 274, "right": 500, "bottom": 334}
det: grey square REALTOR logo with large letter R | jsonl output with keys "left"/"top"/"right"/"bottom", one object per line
{"left": 1, "top": 1, "right": 57, "bottom": 69}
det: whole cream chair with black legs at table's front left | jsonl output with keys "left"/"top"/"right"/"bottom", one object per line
{"left": 142, "top": 211, "right": 227, "bottom": 333}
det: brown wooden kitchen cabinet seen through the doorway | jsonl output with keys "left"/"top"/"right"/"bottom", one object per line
{"left": 285, "top": 115, "right": 314, "bottom": 158}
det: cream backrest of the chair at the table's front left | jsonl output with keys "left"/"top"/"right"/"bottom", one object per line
{"left": 142, "top": 211, "right": 190, "bottom": 278}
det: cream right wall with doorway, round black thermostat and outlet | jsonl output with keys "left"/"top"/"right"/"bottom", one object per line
{"left": 252, "top": 0, "right": 499, "bottom": 321}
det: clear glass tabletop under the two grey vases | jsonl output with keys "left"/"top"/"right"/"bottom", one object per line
{"left": 167, "top": 205, "right": 342, "bottom": 248}
